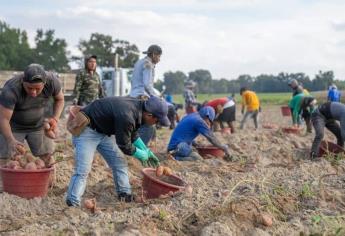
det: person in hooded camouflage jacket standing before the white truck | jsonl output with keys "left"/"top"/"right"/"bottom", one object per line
{"left": 73, "top": 55, "right": 105, "bottom": 106}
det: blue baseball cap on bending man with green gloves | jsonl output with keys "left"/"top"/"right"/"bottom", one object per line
{"left": 145, "top": 96, "right": 170, "bottom": 126}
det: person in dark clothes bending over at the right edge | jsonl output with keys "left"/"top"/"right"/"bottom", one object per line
{"left": 310, "top": 102, "right": 345, "bottom": 159}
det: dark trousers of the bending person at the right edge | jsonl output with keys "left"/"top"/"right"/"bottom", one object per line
{"left": 311, "top": 110, "right": 344, "bottom": 155}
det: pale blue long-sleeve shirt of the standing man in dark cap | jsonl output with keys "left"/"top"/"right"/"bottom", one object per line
{"left": 129, "top": 57, "right": 160, "bottom": 97}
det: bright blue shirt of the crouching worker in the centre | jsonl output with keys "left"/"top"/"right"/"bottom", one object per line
{"left": 168, "top": 112, "right": 213, "bottom": 151}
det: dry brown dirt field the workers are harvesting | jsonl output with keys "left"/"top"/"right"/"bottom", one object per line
{"left": 0, "top": 107, "right": 345, "bottom": 236}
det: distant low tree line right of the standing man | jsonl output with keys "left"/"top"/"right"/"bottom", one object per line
{"left": 156, "top": 69, "right": 345, "bottom": 94}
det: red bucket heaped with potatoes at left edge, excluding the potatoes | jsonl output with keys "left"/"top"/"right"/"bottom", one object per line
{"left": 0, "top": 167, "right": 54, "bottom": 199}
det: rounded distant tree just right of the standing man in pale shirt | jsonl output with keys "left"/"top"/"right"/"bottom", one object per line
{"left": 163, "top": 71, "right": 187, "bottom": 94}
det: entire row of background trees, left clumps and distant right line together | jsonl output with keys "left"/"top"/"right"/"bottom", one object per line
{"left": 0, "top": 21, "right": 345, "bottom": 94}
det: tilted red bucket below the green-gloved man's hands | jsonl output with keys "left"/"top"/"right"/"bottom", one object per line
{"left": 141, "top": 168, "right": 187, "bottom": 198}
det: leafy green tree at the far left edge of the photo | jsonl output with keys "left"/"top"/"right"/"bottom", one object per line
{"left": 0, "top": 21, "right": 32, "bottom": 70}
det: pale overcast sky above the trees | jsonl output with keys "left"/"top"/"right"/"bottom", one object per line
{"left": 0, "top": 0, "right": 345, "bottom": 79}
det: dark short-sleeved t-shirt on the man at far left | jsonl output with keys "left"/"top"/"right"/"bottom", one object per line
{"left": 0, "top": 73, "right": 61, "bottom": 132}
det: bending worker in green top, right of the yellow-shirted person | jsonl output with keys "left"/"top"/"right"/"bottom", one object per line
{"left": 289, "top": 93, "right": 312, "bottom": 133}
